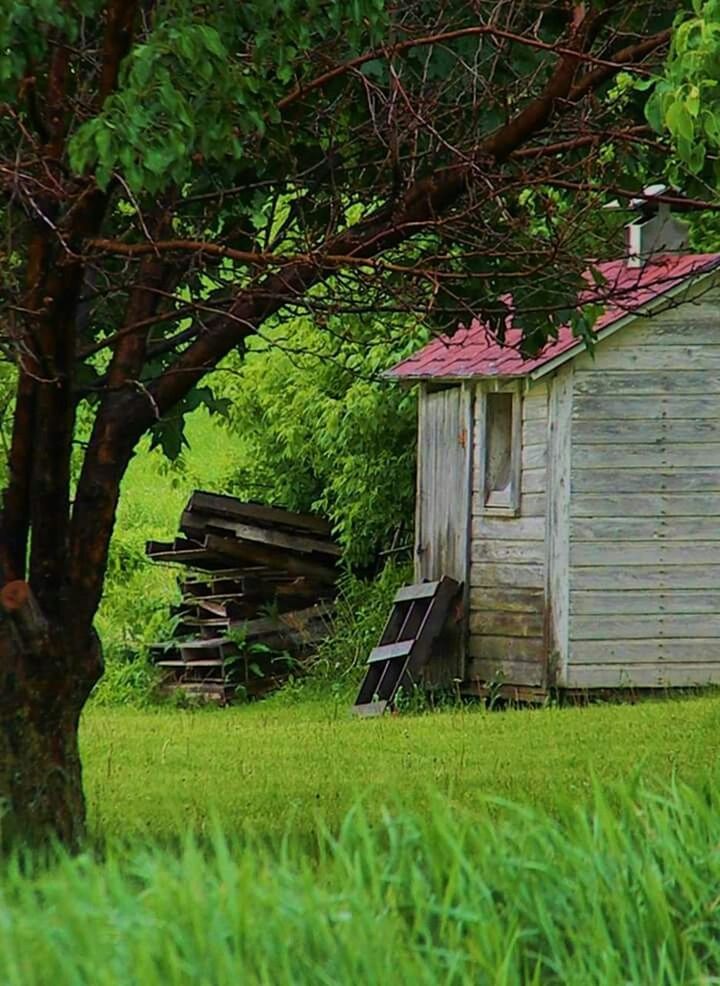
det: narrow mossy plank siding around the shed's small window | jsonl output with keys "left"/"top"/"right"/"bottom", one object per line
{"left": 465, "top": 384, "right": 548, "bottom": 686}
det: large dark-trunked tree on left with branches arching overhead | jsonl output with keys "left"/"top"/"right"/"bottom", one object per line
{"left": 0, "top": 0, "right": 676, "bottom": 845}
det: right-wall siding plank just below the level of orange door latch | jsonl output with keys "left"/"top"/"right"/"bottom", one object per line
{"left": 573, "top": 442, "right": 720, "bottom": 469}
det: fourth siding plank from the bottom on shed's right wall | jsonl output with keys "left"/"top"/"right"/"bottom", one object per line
{"left": 572, "top": 577, "right": 720, "bottom": 616}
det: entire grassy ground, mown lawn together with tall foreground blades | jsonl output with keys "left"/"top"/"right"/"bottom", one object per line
{"left": 0, "top": 696, "right": 720, "bottom": 986}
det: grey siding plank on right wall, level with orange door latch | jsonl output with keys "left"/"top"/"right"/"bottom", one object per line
{"left": 573, "top": 418, "right": 720, "bottom": 446}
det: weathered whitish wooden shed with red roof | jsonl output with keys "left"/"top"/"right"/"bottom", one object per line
{"left": 391, "top": 216, "right": 720, "bottom": 694}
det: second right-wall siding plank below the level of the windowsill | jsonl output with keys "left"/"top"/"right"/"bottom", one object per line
{"left": 570, "top": 540, "right": 720, "bottom": 568}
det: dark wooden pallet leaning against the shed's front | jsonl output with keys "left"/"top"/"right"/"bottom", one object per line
{"left": 352, "top": 576, "right": 462, "bottom": 716}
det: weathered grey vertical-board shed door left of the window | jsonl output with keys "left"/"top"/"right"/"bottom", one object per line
{"left": 415, "top": 385, "right": 472, "bottom": 582}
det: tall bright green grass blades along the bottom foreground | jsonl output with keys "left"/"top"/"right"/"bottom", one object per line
{"left": 0, "top": 786, "right": 720, "bottom": 986}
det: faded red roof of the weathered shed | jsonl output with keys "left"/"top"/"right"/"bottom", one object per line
{"left": 388, "top": 253, "right": 720, "bottom": 380}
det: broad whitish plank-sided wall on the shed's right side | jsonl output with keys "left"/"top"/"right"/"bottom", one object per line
{"left": 564, "top": 292, "right": 720, "bottom": 688}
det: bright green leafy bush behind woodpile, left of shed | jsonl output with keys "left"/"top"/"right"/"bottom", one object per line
{"left": 219, "top": 316, "right": 426, "bottom": 565}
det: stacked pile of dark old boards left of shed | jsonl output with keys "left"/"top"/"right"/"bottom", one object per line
{"left": 146, "top": 490, "right": 340, "bottom": 703}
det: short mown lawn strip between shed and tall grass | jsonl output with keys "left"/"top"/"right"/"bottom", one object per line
{"left": 82, "top": 696, "right": 720, "bottom": 841}
